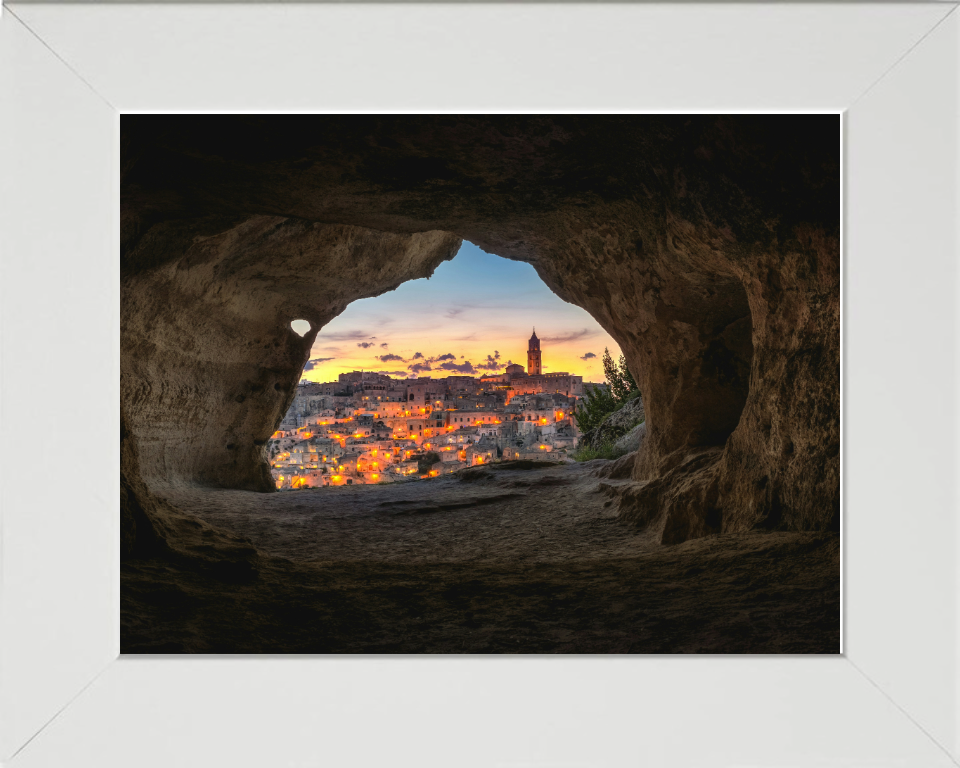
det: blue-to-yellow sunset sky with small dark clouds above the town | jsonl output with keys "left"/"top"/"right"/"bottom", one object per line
{"left": 303, "top": 242, "right": 620, "bottom": 382}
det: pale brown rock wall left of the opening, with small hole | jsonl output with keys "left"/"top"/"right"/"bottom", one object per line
{"left": 121, "top": 216, "right": 460, "bottom": 491}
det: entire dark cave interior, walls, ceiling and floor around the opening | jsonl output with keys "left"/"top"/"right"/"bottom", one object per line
{"left": 120, "top": 115, "right": 840, "bottom": 653}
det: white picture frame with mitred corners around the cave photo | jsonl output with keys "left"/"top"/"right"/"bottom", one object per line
{"left": 0, "top": 2, "right": 960, "bottom": 768}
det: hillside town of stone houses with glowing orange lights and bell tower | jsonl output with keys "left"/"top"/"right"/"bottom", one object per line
{"left": 267, "top": 329, "right": 604, "bottom": 490}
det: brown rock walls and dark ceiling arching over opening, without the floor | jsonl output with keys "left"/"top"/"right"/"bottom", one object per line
{"left": 121, "top": 115, "right": 840, "bottom": 551}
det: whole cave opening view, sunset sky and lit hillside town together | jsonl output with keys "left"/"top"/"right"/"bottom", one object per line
{"left": 265, "top": 241, "right": 628, "bottom": 490}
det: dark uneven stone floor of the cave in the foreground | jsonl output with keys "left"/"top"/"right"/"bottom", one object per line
{"left": 121, "top": 462, "right": 840, "bottom": 653}
